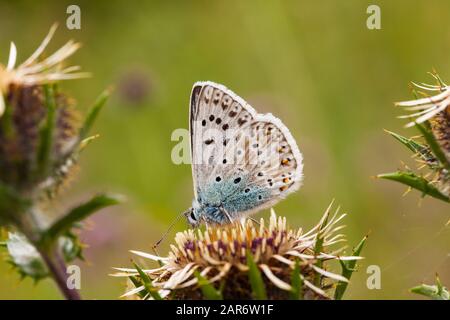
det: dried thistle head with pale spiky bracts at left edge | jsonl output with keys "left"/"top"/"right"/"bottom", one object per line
{"left": 0, "top": 25, "right": 88, "bottom": 190}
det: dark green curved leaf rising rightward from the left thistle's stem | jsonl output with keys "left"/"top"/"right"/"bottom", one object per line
{"left": 42, "top": 194, "right": 121, "bottom": 245}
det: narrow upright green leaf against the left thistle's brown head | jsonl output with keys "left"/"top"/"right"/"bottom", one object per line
{"left": 37, "top": 85, "right": 56, "bottom": 176}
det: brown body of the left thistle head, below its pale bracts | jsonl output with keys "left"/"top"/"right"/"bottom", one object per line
{"left": 0, "top": 85, "right": 80, "bottom": 189}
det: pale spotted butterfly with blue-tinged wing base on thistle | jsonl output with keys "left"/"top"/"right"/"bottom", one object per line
{"left": 184, "top": 81, "right": 303, "bottom": 227}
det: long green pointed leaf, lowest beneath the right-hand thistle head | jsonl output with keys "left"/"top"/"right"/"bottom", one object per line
{"left": 377, "top": 171, "right": 450, "bottom": 202}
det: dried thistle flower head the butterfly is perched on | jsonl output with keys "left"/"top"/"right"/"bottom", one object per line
{"left": 113, "top": 206, "right": 360, "bottom": 299}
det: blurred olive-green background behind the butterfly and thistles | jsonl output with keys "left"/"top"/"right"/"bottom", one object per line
{"left": 0, "top": 0, "right": 450, "bottom": 299}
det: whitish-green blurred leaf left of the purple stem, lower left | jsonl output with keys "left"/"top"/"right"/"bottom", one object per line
{"left": 6, "top": 233, "right": 49, "bottom": 281}
